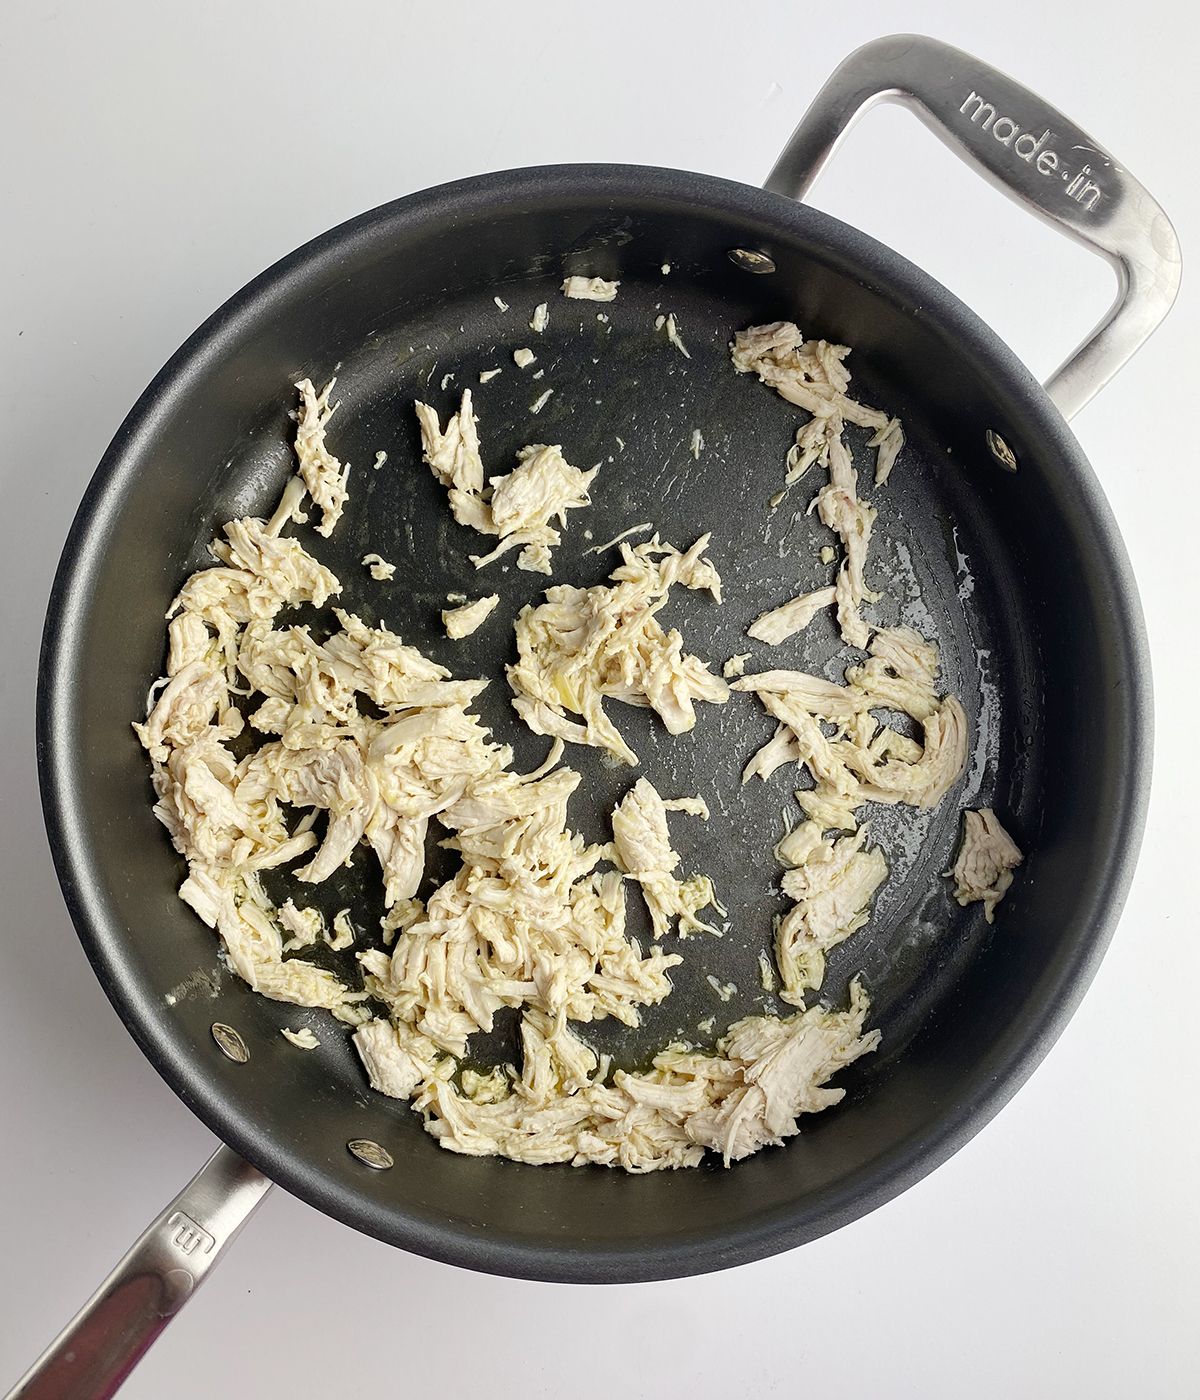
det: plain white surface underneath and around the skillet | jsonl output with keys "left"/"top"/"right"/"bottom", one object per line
{"left": 0, "top": 0, "right": 1200, "bottom": 1400}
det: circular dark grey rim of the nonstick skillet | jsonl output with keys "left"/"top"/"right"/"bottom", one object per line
{"left": 36, "top": 164, "right": 1152, "bottom": 1282}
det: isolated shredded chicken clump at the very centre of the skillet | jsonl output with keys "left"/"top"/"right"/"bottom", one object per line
{"left": 508, "top": 535, "right": 728, "bottom": 764}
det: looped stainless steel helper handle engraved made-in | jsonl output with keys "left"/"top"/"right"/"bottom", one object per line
{"left": 766, "top": 34, "right": 1182, "bottom": 419}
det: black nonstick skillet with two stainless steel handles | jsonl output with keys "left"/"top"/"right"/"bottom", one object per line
{"left": 14, "top": 35, "right": 1179, "bottom": 1396}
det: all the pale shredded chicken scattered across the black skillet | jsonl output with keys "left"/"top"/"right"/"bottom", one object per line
{"left": 134, "top": 312, "right": 968, "bottom": 1172}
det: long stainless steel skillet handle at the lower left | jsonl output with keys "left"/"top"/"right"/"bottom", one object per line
{"left": 6, "top": 1147, "right": 272, "bottom": 1400}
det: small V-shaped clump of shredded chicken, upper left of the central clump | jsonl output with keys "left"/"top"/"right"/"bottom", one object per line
{"left": 416, "top": 389, "right": 599, "bottom": 574}
